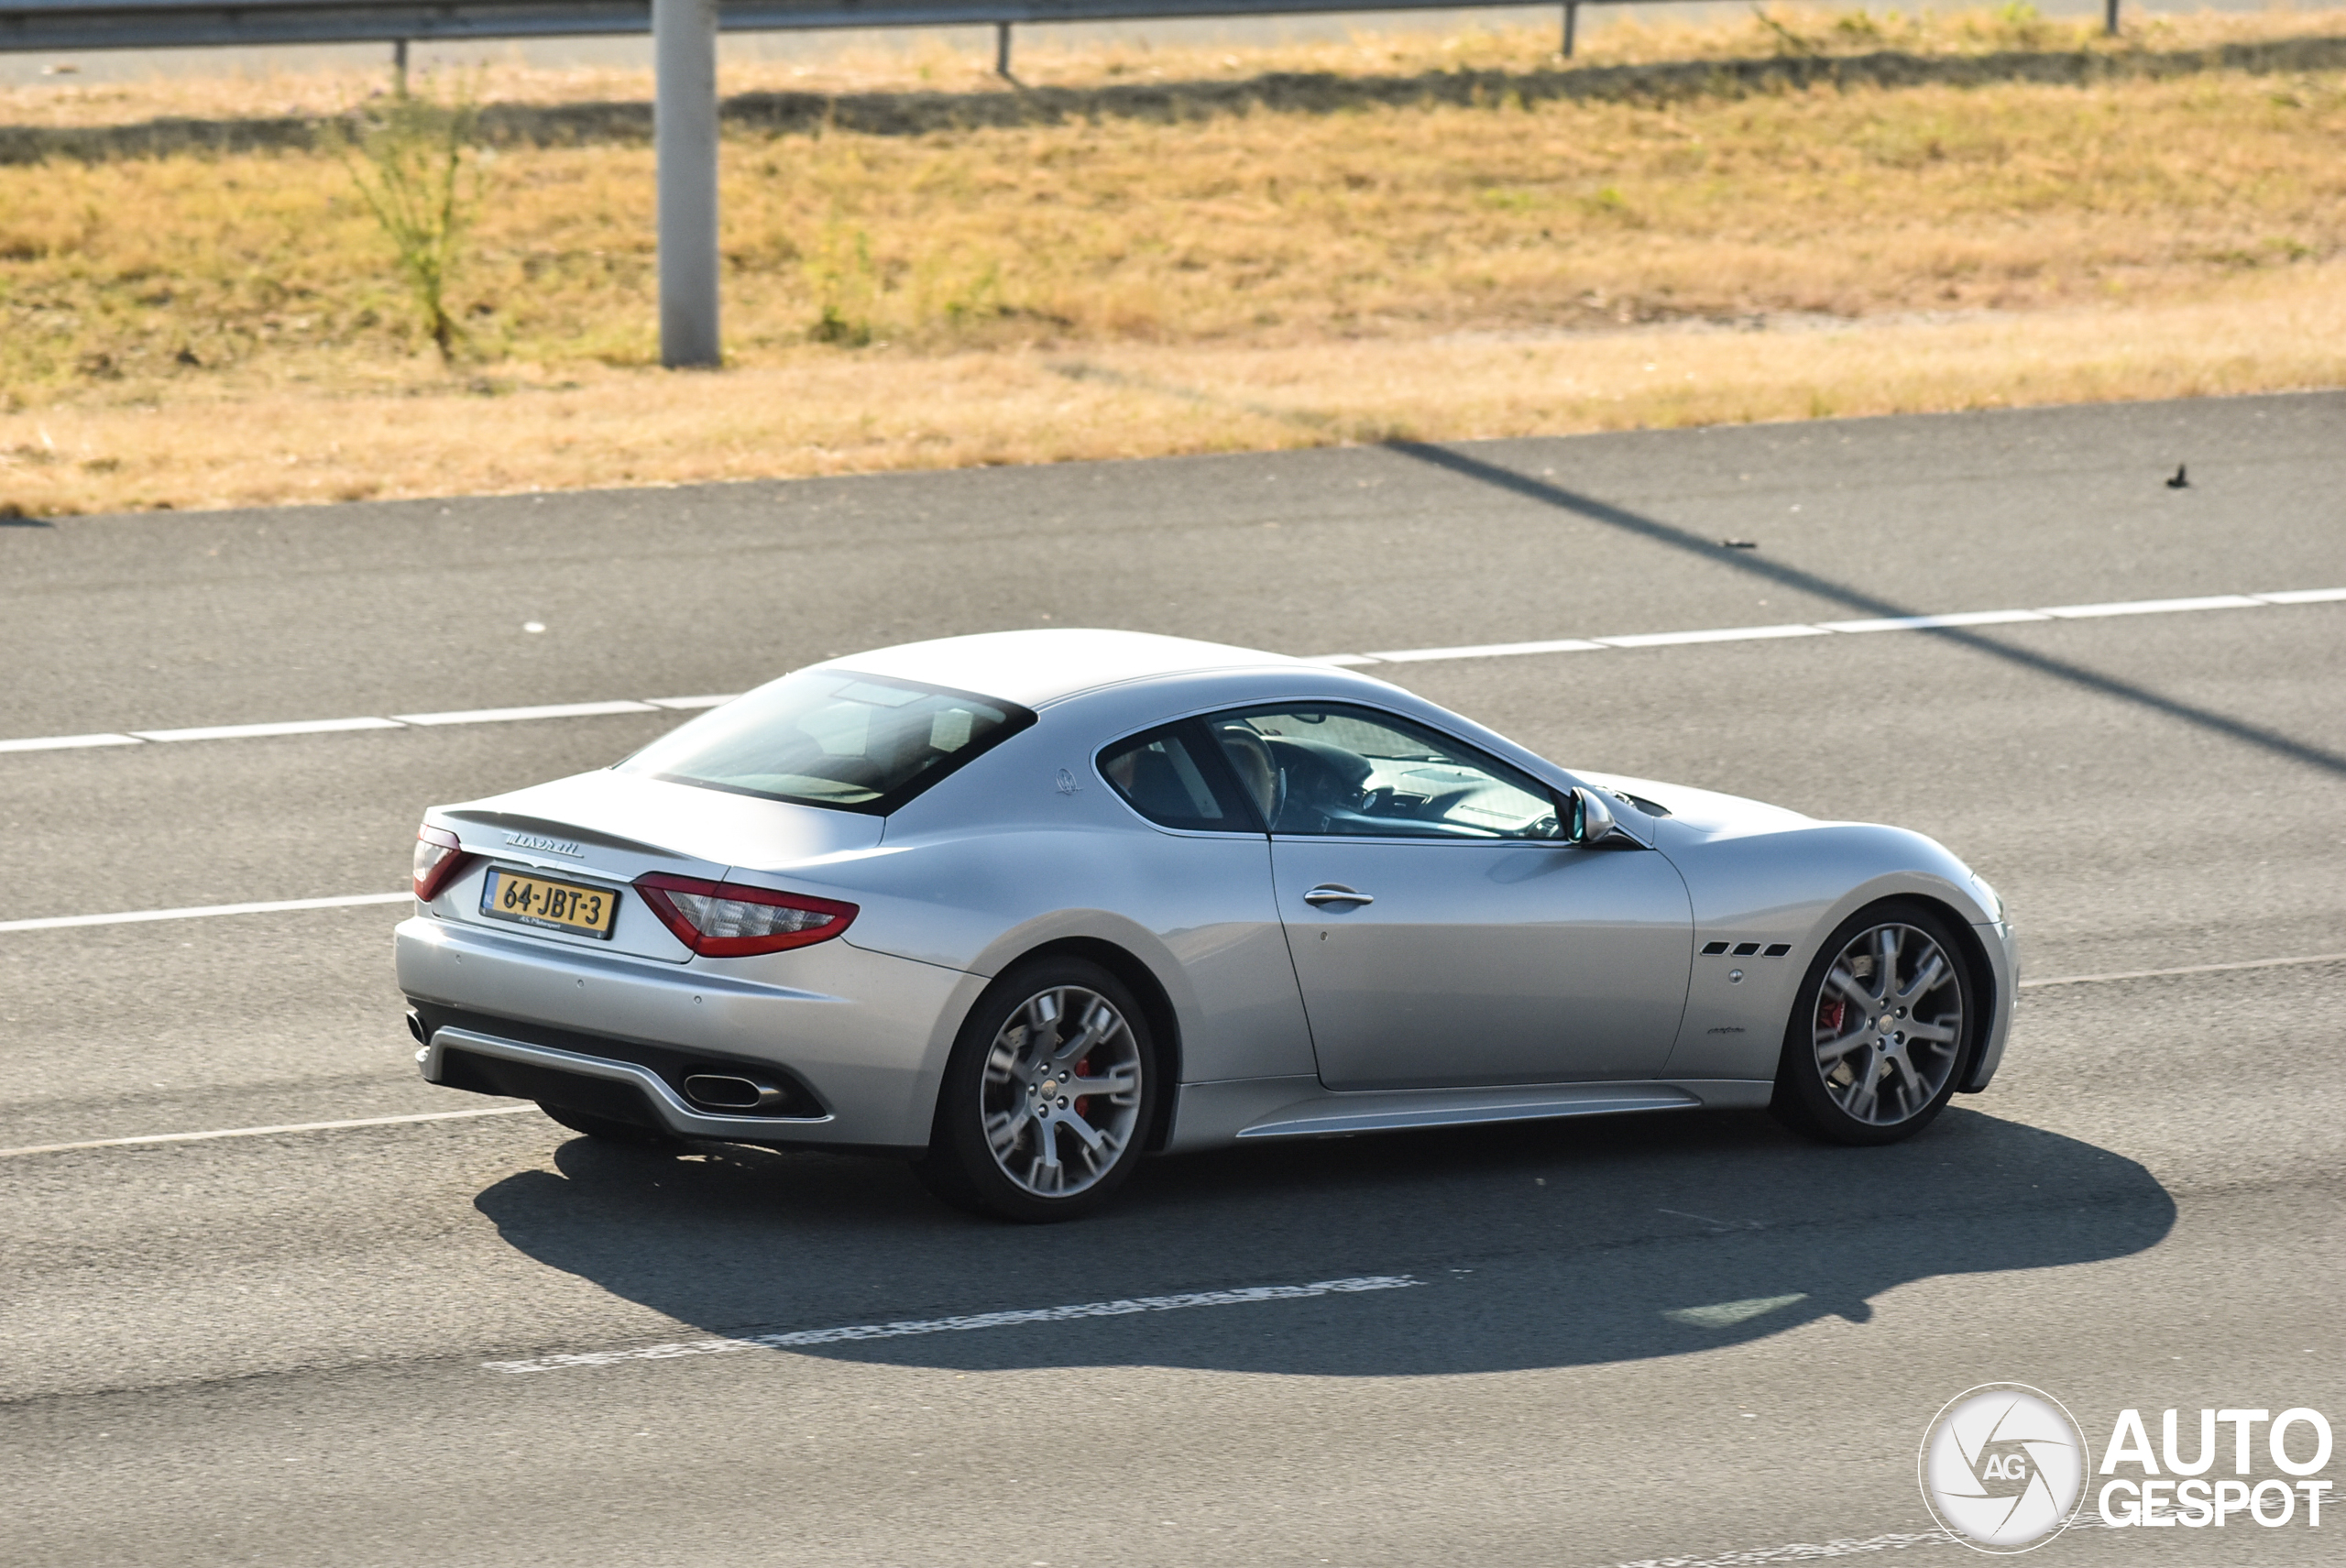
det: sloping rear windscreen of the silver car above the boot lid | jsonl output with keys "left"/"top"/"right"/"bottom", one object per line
{"left": 619, "top": 669, "right": 1035, "bottom": 815}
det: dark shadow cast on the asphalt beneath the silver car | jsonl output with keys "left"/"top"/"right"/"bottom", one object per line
{"left": 477, "top": 1111, "right": 2175, "bottom": 1376}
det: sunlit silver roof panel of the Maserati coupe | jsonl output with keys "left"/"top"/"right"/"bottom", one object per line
{"left": 817, "top": 627, "right": 1311, "bottom": 709}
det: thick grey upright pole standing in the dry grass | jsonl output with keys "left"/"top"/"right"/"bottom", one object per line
{"left": 652, "top": 0, "right": 725, "bottom": 368}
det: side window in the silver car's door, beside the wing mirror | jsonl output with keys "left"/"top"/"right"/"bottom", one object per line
{"left": 1206, "top": 707, "right": 1567, "bottom": 840}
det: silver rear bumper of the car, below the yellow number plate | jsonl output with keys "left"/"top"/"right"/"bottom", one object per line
{"left": 397, "top": 916, "right": 985, "bottom": 1150}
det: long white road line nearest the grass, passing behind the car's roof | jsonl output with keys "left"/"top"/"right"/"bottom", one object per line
{"left": 0, "top": 589, "right": 2346, "bottom": 751}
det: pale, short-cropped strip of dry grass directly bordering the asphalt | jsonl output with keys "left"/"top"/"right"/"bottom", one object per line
{"left": 0, "top": 263, "right": 2346, "bottom": 514}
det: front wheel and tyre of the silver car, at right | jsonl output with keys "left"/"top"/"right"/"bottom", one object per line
{"left": 1771, "top": 899, "right": 1985, "bottom": 1146}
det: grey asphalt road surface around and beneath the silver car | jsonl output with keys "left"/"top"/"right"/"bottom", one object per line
{"left": 0, "top": 397, "right": 2346, "bottom": 1568}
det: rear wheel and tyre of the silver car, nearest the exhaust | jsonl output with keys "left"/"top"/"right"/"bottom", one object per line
{"left": 913, "top": 958, "right": 1161, "bottom": 1225}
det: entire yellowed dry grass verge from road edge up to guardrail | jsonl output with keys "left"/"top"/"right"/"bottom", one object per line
{"left": 0, "top": 14, "right": 2346, "bottom": 511}
